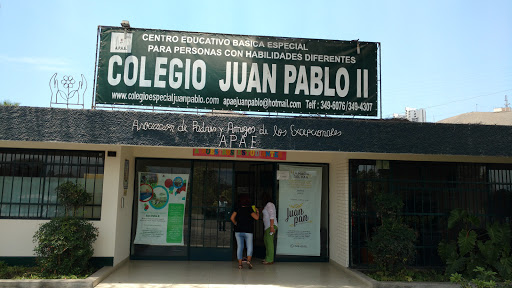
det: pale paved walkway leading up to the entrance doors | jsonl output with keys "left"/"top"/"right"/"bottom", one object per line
{"left": 96, "top": 261, "right": 370, "bottom": 288}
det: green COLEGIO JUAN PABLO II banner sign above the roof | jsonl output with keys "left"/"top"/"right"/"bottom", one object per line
{"left": 95, "top": 27, "right": 377, "bottom": 116}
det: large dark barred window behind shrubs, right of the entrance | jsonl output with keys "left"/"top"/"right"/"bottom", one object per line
{"left": 350, "top": 160, "right": 512, "bottom": 266}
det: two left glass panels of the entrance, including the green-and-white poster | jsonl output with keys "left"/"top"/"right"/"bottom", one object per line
{"left": 130, "top": 159, "right": 234, "bottom": 260}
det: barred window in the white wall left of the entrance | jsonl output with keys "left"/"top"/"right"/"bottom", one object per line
{"left": 0, "top": 148, "right": 105, "bottom": 220}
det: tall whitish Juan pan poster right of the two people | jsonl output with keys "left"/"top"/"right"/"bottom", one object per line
{"left": 276, "top": 165, "right": 322, "bottom": 256}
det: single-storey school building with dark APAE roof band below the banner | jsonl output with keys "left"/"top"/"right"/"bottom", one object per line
{"left": 0, "top": 106, "right": 512, "bottom": 267}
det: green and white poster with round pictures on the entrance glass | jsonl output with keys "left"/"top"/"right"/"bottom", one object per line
{"left": 134, "top": 172, "right": 189, "bottom": 246}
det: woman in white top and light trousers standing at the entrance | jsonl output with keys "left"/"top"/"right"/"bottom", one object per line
{"left": 262, "top": 193, "right": 277, "bottom": 265}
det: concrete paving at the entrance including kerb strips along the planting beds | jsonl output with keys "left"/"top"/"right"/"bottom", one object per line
{"left": 0, "top": 260, "right": 459, "bottom": 288}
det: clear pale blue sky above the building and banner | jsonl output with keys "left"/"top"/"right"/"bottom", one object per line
{"left": 0, "top": 0, "right": 512, "bottom": 122}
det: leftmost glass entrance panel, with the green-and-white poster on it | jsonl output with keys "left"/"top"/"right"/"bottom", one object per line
{"left": 130, "top": 159, "right": 192, "bottom": 260}
